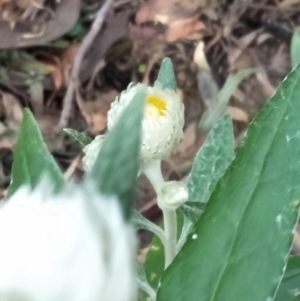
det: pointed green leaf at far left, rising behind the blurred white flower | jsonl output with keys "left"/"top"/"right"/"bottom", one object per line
{"left": 7, "top": 109, "right": 65, "bottom": 197}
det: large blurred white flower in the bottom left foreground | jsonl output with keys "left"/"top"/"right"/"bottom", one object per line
{"left": 0, "top": 180, "right": 136, "bottom": 301}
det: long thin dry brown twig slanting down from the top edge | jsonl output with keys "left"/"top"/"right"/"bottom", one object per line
{"left": 56, "top": 0, "right": 114, "bottom": 132}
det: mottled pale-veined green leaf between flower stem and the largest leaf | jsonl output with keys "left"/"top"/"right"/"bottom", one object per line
{"left": 182, "top": 115, "right": 234, "bottom": 222}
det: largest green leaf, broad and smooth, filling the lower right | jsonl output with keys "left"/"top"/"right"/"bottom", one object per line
{"left": 157, "top": 63, "right": 300, "bottom": 301}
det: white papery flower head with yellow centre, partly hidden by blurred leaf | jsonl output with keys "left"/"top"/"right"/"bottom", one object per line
{"left": 83, "top": 81, "right": 184, "bottom": 171}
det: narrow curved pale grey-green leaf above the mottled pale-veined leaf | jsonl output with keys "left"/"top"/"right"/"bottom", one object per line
{"left": 199, "top": 69, "right": 257, "bottom": 130}
